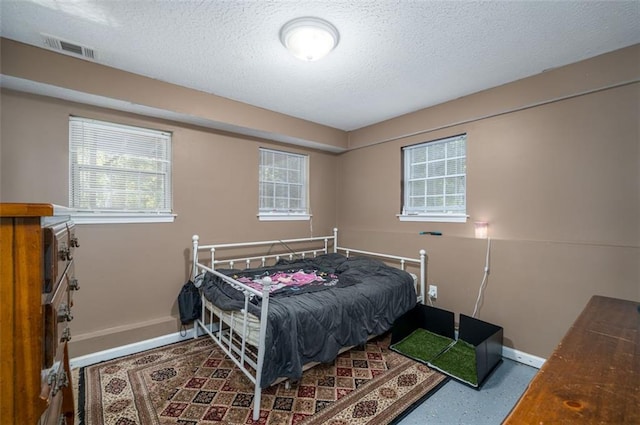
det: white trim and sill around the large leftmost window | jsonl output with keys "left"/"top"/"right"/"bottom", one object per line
{"left": 67, "top": 115, "right": 177, "bottom": 224}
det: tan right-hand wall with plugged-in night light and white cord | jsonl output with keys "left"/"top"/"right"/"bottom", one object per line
{"left": 337, "top": 46, "right": 640, "bottom": 357}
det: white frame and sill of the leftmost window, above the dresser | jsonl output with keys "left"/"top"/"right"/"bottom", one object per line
{"left": 69, "top": 116, "right": 176, "bottom": 224}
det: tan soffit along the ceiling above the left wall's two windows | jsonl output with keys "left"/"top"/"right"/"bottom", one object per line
{"left": 0, "top": 38, "right": 347, "bottom": 151}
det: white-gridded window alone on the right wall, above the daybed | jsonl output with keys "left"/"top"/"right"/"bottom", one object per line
{"left": 399, "top": 134, "right": 467, "bottom": 222}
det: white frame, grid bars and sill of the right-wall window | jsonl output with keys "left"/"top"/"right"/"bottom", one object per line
{"left": 397, "top": 133, "right": 469, "bottom": 223}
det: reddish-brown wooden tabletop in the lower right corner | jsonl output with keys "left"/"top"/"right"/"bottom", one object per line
{"left": 503, "top": 296, "right": 640, "bottom": 425}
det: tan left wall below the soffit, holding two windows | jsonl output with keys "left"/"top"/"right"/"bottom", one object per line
{"left": 0, "top": 91, "right": 337, "bottom": 356}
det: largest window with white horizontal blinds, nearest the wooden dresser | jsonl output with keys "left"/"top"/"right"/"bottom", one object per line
{"left": 69, "top": 117, "right": 174, "bottom": 223}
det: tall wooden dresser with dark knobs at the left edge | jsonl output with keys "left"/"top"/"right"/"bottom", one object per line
{"left": 0, "top": 203, "right": 79, "bottom": 425}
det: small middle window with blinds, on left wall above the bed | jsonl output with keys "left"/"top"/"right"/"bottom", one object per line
{"left": 258, "top": 148, "right": 310, "bottom": 220}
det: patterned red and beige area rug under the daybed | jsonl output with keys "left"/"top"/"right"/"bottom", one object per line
{"left": 77, "top": 337, "right": 447, "bottom": 425}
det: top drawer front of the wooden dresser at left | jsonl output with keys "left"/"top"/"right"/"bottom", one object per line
{"left": 42, "top": 222, "right": 79, "bottom": 293}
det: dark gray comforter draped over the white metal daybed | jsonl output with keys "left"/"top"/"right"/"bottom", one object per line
{"left": 202, "top": 254, "right": 416, "bottom": 388}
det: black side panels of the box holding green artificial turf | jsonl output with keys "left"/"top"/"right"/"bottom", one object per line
{"left": 391, "top": 304, "right": 503, "bottom": 389}
